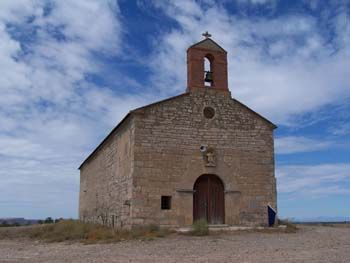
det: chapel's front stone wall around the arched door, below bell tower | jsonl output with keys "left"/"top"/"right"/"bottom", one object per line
{"left": 131, "top": 89, "right": 276, "bottom": 226}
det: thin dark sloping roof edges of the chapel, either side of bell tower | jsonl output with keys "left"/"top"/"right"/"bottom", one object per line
{"left": 78, "top": 92, "right": 277, "bottom": 170}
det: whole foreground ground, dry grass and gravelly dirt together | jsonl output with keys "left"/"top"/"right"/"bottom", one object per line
{"left": 0, "top": 222, "right": 350, "bottom": 263}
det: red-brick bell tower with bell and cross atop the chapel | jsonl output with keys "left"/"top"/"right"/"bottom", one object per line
{"left": 187, "top": 32, "right": 229, "bottom": 92}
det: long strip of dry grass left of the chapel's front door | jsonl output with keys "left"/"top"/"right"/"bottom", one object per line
{"left": 0, "top": 220, "right": 169, "bottom": 243}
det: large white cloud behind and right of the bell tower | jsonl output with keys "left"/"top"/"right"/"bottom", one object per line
{"left": 148, "top": 2, "right": 350, "bottom": 125}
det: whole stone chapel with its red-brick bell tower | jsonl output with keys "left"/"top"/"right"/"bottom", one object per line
{"left": 79, "top": 34, "right": 277, "bottom": 228}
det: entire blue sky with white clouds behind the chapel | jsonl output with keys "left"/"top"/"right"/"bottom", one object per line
{"left": 0, "top": 0, "right": 350, "bottom": 222}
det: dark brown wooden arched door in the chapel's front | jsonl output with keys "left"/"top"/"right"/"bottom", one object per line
{"left": 193, "top": 174, "right": 225, "bottom": 224}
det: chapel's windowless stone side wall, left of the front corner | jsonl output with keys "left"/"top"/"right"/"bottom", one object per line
{"left": 79, "top": 118, "right": 134, "bottom": 228}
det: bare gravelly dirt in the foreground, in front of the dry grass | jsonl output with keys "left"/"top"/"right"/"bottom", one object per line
{"left": 0, "top": 226, "right": 350, "bottom": 263}
